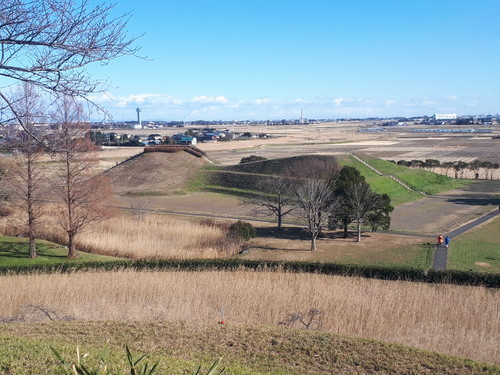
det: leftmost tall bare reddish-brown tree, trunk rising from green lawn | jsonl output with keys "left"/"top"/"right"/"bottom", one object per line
{"left": 3, "top": 83, "right": 45, "bottom": 258}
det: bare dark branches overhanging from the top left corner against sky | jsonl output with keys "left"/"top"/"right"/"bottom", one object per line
{"left": 0, "top": 0, "right": 137, "bottom": 138}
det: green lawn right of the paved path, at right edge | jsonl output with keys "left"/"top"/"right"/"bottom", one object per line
{"left": 448, "top": 217, "right": 500, "bottom": 273}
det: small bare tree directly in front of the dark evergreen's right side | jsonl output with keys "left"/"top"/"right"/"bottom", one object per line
{"left": 343, "top": 181, "right": 381, "bottom": 242}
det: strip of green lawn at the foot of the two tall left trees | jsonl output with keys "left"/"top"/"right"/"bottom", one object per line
{"left": 0, "top": 237, "right": 119, "bottom": 266}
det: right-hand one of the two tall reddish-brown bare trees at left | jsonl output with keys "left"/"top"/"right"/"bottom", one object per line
{"left": 52, "top": 96, "right": 116, "bottom": 258}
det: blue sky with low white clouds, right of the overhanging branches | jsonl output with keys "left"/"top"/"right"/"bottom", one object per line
{"left": 89, "top": 0, "right": 500, "bottom": 121}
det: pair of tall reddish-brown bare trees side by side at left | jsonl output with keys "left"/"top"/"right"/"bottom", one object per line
{"left": 2, "top": 83, "right": 112, "bottom": 258}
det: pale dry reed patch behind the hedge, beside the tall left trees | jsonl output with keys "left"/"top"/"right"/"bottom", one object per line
{"left": 0, "top": 211, "right": 241, "bottom": 259}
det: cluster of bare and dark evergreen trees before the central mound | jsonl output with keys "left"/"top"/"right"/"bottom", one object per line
{"left": 247, "top": 166, "right": 393, "bottom": 250}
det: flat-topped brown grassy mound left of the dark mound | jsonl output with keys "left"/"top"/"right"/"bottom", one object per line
{"left": 105, "top": 152, "right": 208, "bottom": 195}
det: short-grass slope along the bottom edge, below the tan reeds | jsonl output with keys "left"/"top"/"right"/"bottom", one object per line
{"left": 0, "top": 322, "right": 500, "bottom": 375}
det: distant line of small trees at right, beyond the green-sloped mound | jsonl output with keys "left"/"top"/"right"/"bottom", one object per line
{"left": 389, "top": 159, "right": 500, "bottom": 180}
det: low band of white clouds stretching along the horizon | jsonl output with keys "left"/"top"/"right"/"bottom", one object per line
{"left": 91, "top": 93, "right": 479, "bottom": 121}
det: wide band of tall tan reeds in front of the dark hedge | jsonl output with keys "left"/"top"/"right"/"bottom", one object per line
{"left": 0, "top": 271, "right": 500, "bottom": 364}
